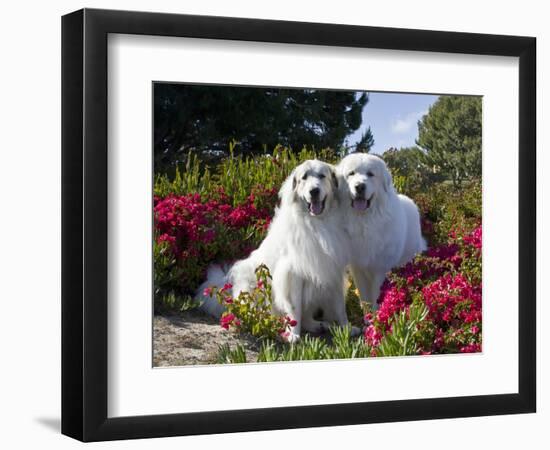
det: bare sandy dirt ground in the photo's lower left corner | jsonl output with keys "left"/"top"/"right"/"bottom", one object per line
{"left": 153, "top": 310, "right": 258, "bottom": 367}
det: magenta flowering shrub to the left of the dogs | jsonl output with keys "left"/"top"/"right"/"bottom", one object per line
{"left": 154, "top": 187, "right": 276, "bottom": 306}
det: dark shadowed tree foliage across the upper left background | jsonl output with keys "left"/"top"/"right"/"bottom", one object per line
{"left": 154, "top": 83, "right": 372, "bottom": 174}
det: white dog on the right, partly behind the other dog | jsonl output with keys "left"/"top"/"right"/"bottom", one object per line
{"left": 337, "top": 153, "right": 432, "bottom": 308}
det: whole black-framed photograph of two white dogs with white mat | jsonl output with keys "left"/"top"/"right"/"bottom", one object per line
{"left": 62, "top": 9, "right": 536, "bottom": 441}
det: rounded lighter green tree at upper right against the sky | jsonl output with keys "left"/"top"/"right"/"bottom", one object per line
{"left": 416, "top": 95, "right": 482, "bottom": 187}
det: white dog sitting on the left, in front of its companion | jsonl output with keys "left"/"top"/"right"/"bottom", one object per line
{"left": 198, "top": 160, "right": 349, "bottom": 342}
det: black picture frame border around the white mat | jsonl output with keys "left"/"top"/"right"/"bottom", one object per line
{"left": 62, "top": 9, "right": 536, "bottom": 441}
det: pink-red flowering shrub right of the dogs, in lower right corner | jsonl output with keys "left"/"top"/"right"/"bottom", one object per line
{"left": 364, "top": 225, "right": 482, "bottom": 356}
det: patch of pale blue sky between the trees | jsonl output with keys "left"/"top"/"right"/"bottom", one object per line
{"left": 348, "top": 92, "right": 444, "bottom": 153}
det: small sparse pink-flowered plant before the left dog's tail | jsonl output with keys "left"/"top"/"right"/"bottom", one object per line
{"left": 204, "top": 265, "right": 297, "bottom": 338}
